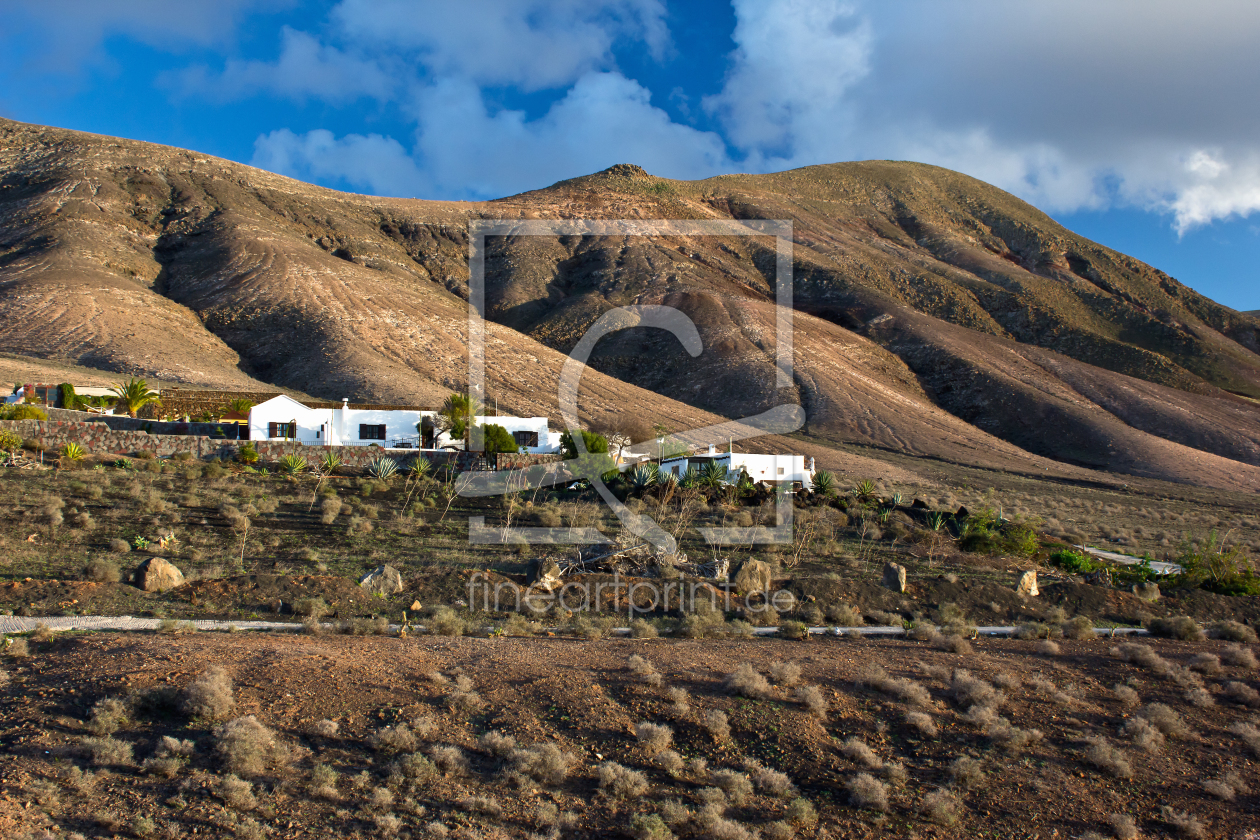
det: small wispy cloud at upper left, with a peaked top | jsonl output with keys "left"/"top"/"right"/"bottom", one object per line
{"left": 172, "top": 26, "right": 394, "bottom": 102}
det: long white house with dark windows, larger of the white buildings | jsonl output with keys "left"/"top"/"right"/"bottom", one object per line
{"left": 249, "top": 394, "right": 559, "bottom": 453}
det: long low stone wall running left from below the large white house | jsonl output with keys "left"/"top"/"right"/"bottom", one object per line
{"left": 0, "top": 418, "right": 559, "bottom": 471}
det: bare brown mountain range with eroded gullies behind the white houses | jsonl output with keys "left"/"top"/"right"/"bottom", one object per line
{"left": 0, "top": 121, "right": 1260, "bottom": 490}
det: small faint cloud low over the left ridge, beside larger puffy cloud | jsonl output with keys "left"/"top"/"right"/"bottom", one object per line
{"left": 249, "top": 128, "right": 427, "bottom": 196}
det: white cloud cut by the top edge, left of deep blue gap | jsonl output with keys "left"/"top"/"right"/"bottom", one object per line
{"left": 331, "top": 0, "right": 669, "bottom": 91}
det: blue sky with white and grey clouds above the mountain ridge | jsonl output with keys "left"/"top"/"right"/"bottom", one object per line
{"left": 0, "top": 0, "right": 1260, "bottom": 310}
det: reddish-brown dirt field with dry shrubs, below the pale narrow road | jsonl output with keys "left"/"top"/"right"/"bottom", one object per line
{"left": 0, "top": 633, "right": 1260, "bottom": 839}
